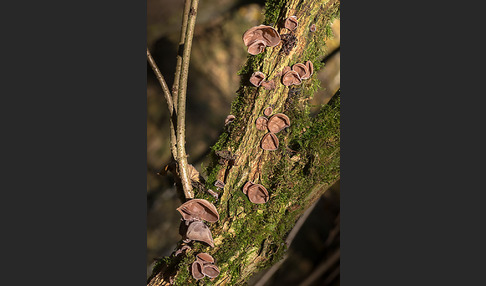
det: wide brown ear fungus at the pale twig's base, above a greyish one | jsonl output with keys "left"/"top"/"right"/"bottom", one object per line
{"left": 177, "top": 199, "right": 219, "bottom": 222}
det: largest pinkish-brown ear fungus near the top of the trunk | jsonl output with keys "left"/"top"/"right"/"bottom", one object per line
{"left": 243, "top": 25, "right": 280, "bottom": 55}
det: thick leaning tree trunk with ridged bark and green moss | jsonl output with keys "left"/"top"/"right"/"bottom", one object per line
{"left": 148, "top": 0, "right": 340, "bottom": 286}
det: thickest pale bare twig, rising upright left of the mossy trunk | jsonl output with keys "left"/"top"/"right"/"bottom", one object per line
{"left": 177, "top": 0, "right": 199, "bottom": 199}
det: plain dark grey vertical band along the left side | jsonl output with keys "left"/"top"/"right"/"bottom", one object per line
{"left": 0, "top": 0, "right": 147, "bottom": 285}
